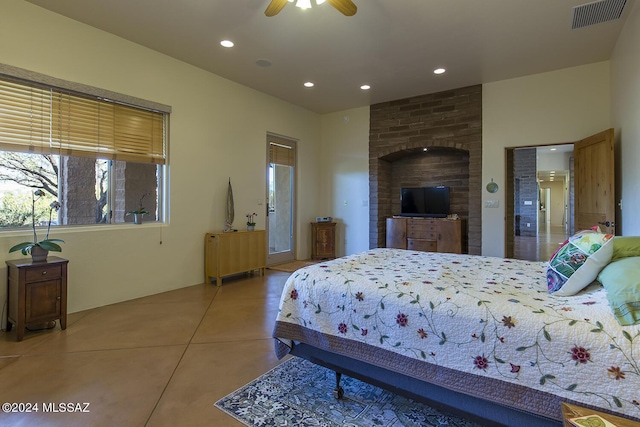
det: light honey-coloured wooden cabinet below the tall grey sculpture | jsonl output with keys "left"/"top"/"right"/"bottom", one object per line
{"left": 204, "top": 230, "right": 267, "bottom": 286}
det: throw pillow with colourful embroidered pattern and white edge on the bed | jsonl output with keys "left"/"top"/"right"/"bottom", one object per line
{"left": 547, "top": 230, "right": 613, "bottom": 296}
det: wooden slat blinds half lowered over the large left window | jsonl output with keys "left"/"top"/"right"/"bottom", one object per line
{"left": 0, "top": 76, "right": 166, "bottom": 164}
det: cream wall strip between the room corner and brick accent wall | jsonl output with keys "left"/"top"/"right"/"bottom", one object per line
{"left": 318, "top": 107, "right": 369, "bottom": 256}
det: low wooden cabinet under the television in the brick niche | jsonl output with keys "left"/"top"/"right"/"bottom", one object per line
{"left": 386, "top": 217, "right": 466, "bottom": 254}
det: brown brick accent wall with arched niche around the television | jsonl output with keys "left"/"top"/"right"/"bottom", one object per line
{"left": 369, "top": 85, "right": 482, "bottom": 254}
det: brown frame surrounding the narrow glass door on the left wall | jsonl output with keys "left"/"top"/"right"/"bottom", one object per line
{"left": 265, "top": 132, "right": 298, "bottom": 265}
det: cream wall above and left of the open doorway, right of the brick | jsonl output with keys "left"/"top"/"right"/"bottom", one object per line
{"left": 482, "top": 61, "right": 611, "bottom": 257}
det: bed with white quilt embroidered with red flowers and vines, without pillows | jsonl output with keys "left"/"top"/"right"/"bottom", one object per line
{"left": 273, "top": 248, "right": 640, "bottom": 426}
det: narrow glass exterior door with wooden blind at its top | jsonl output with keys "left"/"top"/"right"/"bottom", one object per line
{"left": 266, "top": 134, "right": 296, "bottom": 265}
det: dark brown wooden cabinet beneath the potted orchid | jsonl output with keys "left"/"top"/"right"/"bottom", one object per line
{"left": 7, "top": 256, "right": 69, "bottom": 341}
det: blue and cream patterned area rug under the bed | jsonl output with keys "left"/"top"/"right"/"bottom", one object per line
{"left": 215, "top": 357, "right": 480, "bottom": 427}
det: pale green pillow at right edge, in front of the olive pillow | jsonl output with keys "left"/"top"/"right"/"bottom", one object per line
{"left": 598, "top": 256, "right": 640, "bottom": 326}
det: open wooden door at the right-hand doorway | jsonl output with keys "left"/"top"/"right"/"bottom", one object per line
{"left": 574, "top": 129, "right": 616, "bottom": 234}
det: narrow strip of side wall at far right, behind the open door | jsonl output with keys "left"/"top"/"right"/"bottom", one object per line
{"left": 611, "top": 2, "right": 640, "bottom": 236}
